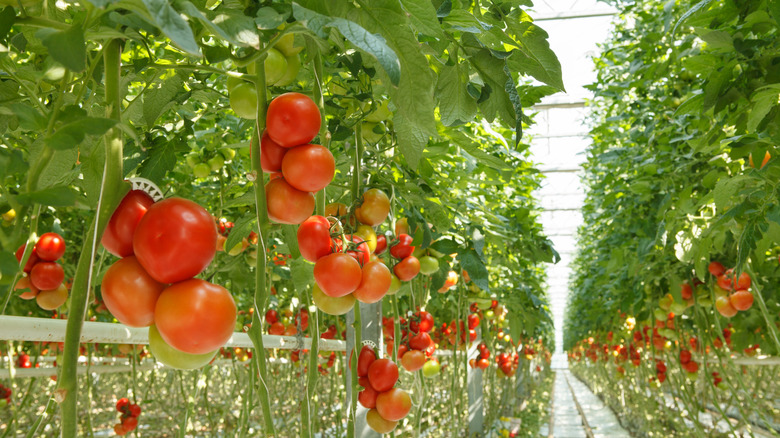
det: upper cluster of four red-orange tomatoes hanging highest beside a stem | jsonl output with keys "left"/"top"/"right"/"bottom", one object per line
{"left": 260, "top": 93, "right": 336, "bottom": 224}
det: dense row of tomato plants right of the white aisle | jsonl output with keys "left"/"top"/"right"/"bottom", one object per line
{"left": 565, "top": 1, "right": 780, "bottom": 436}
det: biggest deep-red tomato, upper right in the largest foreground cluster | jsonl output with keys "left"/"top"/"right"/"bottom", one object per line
{"left": 133, "top": 198, "right": 217, "bottom": 284}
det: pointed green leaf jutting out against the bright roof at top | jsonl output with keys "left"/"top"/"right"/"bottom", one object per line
{"left": 506, "top": 21, "right": 566, "bottom": 91}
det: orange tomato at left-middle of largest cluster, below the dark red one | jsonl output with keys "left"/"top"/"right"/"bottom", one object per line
{"left": 100, "top": 256, "right": 165, "bottom": 327}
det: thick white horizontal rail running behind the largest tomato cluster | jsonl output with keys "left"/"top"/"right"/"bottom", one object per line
{"left": 0, "top": 316, "right": 347, "bottom": 351}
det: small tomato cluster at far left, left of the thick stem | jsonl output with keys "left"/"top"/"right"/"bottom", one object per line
{"left": 14, "top": 233, "right": 68, "bottom": 310}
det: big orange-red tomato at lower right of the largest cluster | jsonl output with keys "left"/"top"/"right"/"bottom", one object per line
{"left": 150, "top": 278, "right": 236, "bottom": 354}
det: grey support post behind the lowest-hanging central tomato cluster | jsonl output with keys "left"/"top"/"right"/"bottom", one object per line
{"left": 344, "top": 301, "right": 384, "bottom": 438}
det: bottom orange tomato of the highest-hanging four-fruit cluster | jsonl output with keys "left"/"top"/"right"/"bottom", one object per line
{"left": 265, "top": 178, "right": 314, "bottom": 224}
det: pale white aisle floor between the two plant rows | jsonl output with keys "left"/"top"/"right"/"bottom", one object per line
{"left": 550, "top": 370, "right": 631, "bottom": 438}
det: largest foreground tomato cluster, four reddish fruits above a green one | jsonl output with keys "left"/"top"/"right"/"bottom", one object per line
{"left": 101, "top": 190, "right": 236, "bottom": 369}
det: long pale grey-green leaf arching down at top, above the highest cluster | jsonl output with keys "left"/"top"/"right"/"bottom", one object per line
{"left": 293, "top": 3, "right": 401, "bottom": 85}
